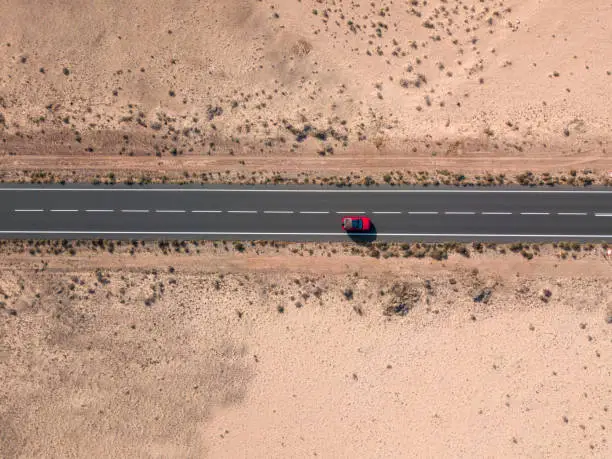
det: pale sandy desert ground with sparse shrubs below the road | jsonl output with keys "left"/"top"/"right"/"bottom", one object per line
{"left": 0, "top": 244, "right": 612, "bottom": 458}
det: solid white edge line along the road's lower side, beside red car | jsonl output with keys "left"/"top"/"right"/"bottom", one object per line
{"left": 0, "top": 232, "right": 612, "bottom": 239}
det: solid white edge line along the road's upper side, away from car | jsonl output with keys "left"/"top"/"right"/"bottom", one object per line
{"left": 0, "top": 187, "right": 612, "bottom": 194}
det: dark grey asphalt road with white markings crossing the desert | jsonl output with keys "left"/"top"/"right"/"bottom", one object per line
{"left": 0, "top": 185, "right": 612, "bottom": 241}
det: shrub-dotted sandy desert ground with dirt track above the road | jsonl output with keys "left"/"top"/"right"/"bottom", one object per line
{"left": 0, "top": 0, "right": 612, "bottom": 180}
